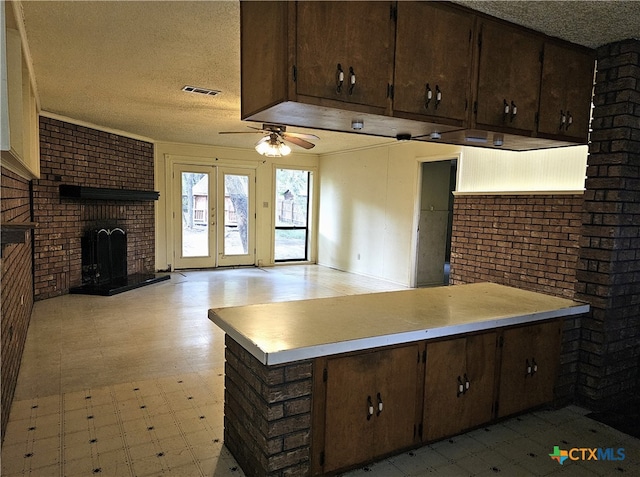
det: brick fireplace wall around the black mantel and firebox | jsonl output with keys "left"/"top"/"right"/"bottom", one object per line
{"left": 33, "top": 117, "right": 155, "bottom": 300}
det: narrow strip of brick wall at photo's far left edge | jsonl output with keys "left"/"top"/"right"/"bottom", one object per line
{"left": 0, "top": 168, "right": 33, "bottom": 439}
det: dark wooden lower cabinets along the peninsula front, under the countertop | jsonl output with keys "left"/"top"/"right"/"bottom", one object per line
{"left": 311, "top": 319, "right": 562, "bottom": 475}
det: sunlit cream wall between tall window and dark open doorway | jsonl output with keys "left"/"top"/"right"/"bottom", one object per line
{"left": 318, "top": 142, "right": 460, "bottom": 286}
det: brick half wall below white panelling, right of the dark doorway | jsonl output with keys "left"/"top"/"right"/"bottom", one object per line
{"left": 450, "top": 195, "right": 582, "bottom": 298}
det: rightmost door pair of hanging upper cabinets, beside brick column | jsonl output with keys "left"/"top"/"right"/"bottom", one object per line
{"left": 538, "top": 43, "right": 595, "bottom": 142}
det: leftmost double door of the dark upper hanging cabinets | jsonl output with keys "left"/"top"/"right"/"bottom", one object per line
{"left": 296, "top": 2, "right": 395, "bottom": 108}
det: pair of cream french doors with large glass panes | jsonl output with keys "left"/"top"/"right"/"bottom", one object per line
{"left": 173, "top": 164, "right": 255, "bottom": 269}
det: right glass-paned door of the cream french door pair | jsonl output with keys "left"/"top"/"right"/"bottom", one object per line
{"left": 217, "top": 167, "right": 256, "bottom": 266}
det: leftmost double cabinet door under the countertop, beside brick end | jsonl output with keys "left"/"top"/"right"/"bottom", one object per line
{"left": 323, "top": 345, "right": 419, "bottom": 473}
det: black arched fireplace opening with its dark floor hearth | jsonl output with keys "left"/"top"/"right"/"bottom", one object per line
{"left": 69, "top": 226, "right": 170, "bottom": 296}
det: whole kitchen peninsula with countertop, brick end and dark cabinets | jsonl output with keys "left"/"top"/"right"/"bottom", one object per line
{"left": 209, "top": 283, "right": 589, "bottom": 476}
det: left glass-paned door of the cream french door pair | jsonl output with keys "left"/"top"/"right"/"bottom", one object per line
{"left": 173, "top": 164, "right": 217, "bottom": 268}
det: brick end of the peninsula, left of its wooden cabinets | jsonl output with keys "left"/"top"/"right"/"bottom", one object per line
{"left": 224, "top": 335, "right": 313, "bottom": 477}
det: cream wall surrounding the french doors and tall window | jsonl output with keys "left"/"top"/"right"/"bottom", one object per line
{"left": 154, "top": 142, "right": 318, "bottom": 270}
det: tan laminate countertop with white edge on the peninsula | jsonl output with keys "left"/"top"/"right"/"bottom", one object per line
{"left": 209, "top": 283, "right": 589, "bottom": 365}
